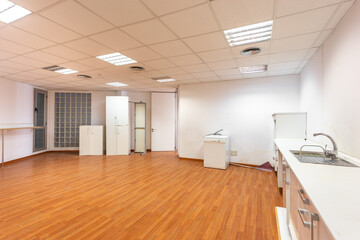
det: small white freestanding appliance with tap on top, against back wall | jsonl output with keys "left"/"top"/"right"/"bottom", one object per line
{"left": 204, "top": 135, "right": 230, "bottom": 169}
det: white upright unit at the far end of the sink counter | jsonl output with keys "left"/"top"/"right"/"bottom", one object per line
{"left": 271, "top": 112, "right": 307, "bottom": 188}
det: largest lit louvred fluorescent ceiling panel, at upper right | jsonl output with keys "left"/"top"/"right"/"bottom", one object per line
{"left": 224, "top": 20, "right": 273, "bottom": 47}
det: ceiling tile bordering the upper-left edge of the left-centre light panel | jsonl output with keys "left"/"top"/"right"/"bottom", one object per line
{"left": 64, "top": 38, "right": 113, "bottom": 56}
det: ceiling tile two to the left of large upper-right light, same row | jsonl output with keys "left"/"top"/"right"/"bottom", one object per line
{"left": 149, "top": 40, "right": 192, "bottom": 57}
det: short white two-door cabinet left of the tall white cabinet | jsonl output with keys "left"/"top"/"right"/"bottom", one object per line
{"left": 79, "top": 126, "right": 104, "bottom": 155}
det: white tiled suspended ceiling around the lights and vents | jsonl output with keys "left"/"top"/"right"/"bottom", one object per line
{"left": 0, "top": 0, "right": 354, "bottom": 91}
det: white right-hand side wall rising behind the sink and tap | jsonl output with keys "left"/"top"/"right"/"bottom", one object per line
{"left": 301, "top": 1, "right": 360, "bottom": 158}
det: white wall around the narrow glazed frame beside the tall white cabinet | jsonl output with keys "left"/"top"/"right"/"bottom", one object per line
{"left": 119, "top": 91, "right": 151, "bottom": 149}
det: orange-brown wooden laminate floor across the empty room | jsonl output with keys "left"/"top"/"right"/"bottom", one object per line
{"left": 0, "top": 152, "right": 282, "bottom": 240}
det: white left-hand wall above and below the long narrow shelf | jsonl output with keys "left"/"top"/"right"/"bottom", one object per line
{"left": 0, "top": 78, "right": 41, "bottom": 161}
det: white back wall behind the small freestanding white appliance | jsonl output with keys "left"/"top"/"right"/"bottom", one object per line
{"left": 178, "top": 75, "right": 300, "bottom": 165}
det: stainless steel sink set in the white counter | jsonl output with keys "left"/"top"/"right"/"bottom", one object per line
{"left": 290, "top": 150, "right": 358, "bottom": 167}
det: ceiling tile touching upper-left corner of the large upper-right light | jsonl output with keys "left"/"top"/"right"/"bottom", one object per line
{"left": 161, "top": 4, "right": 219, "bottom": 38}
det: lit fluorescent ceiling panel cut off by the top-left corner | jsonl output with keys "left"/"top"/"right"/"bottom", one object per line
{"left": 0, "top": 0, "right": 31, "bottom": 23}
